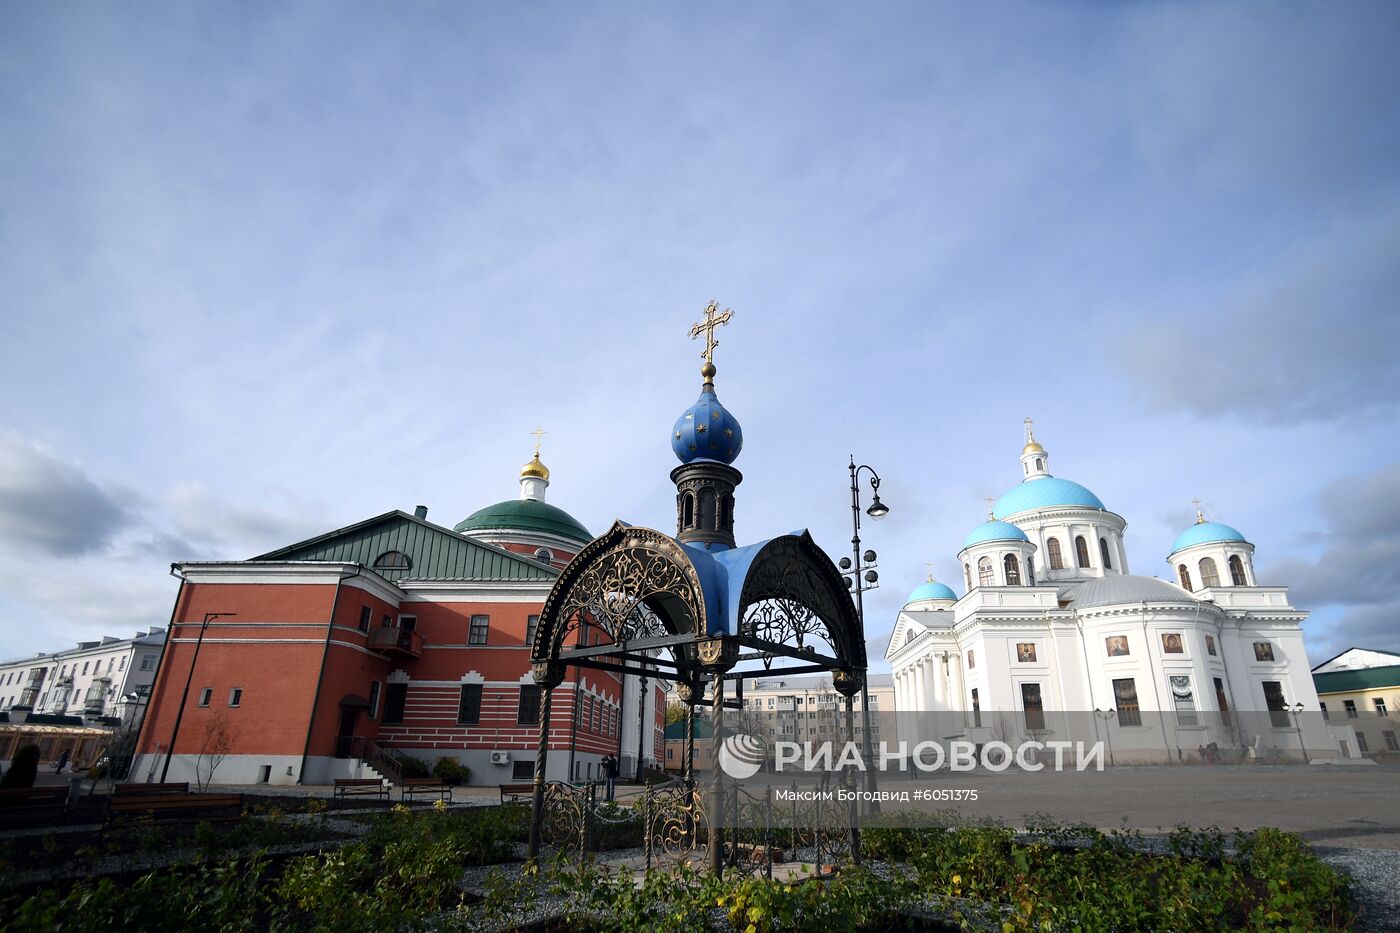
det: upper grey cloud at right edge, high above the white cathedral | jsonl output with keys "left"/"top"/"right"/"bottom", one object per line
{"left": 1114, "top": 212, "right": 1400, "bottom": 424}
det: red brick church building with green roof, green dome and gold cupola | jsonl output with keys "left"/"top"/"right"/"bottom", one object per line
{"left": 132, "top": 452, "right": 665, "bottom": 785}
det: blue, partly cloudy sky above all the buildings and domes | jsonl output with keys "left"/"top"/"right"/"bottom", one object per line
{"left": 0, "top": 1, "right": 1400, "bottom": 671}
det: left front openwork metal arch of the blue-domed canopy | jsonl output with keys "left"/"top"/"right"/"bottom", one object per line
{"left": 531, "top": 521, "right": 706, "bottom": 681}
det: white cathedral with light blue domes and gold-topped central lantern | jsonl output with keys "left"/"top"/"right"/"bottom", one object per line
{"left": 885, "top": 420, "right": 1338, "bottom": 763}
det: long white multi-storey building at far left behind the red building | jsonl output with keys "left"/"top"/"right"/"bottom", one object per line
{"left": 0, "top": 628, "right": 165, "bottom": 726}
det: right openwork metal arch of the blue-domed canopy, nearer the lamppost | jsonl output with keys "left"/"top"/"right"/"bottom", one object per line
{"left": 738, "top": 531, "right": 865, "bottom": 672}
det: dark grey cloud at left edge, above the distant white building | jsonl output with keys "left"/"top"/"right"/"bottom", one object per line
{"left": 0, "top": 430, "right": 134, "bottom": 558}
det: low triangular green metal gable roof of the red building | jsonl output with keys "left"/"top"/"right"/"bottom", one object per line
{"left": 253, "top": 511, "right": 559, "bottom": 583}
